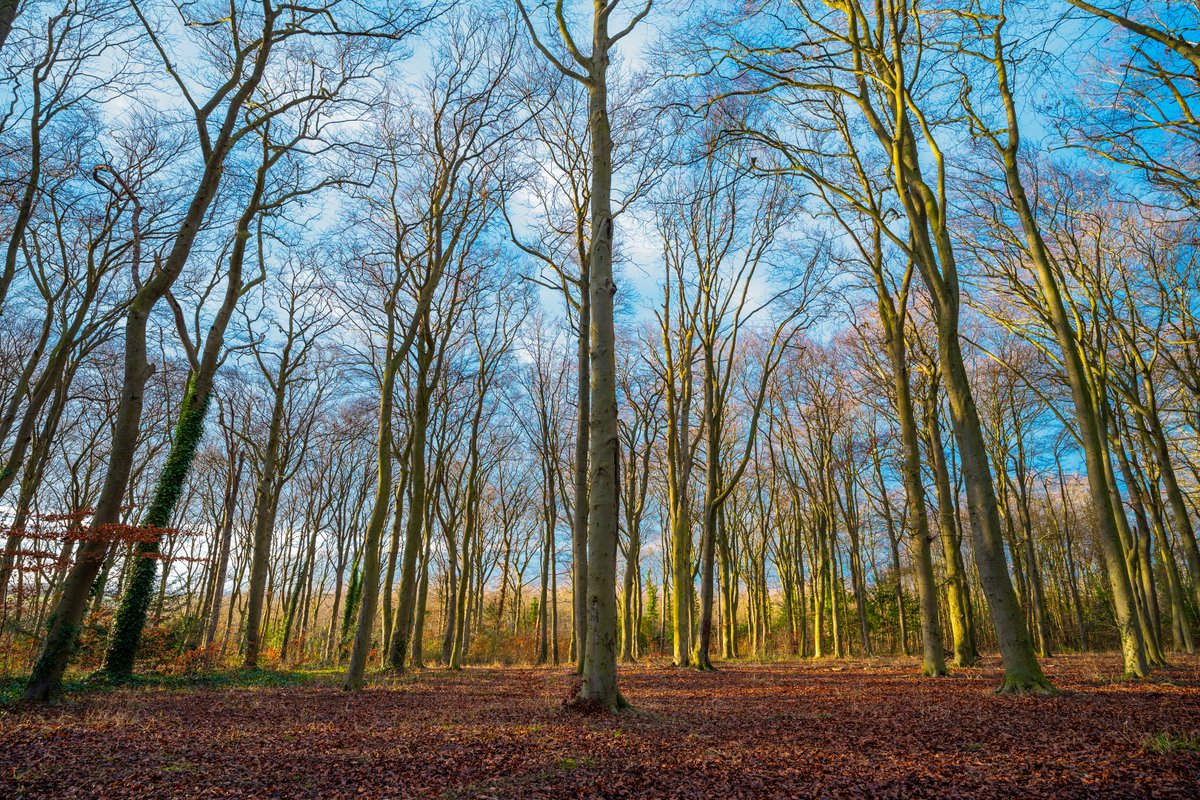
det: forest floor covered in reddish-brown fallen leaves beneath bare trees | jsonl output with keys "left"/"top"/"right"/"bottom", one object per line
{"left": 0, "top": 656, "right": 1200, "bottom": 800}
